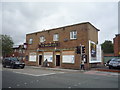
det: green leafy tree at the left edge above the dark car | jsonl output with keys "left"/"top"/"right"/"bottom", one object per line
{"left": 0, "top": 35, "right": 14, "bottom": 57}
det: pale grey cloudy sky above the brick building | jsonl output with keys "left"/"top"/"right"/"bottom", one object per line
{"left": 0, "top": 2, "right": 118, "bottom": 45}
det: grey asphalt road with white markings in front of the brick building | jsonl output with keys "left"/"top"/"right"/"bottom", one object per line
{"left": 2, "top": 67, "right": 118, "bottom": 88}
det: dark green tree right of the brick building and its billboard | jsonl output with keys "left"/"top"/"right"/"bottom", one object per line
{"left": 101, "top": 40, "right": 114, "bottom": 53}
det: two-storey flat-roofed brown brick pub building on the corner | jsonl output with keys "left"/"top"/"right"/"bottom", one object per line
{"left": 25, "top": 22, "right": 101, "bottom": 69}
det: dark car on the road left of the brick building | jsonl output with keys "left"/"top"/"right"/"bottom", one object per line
{"left": 2, "top": 57, "right": 25, "bottom": 69}
